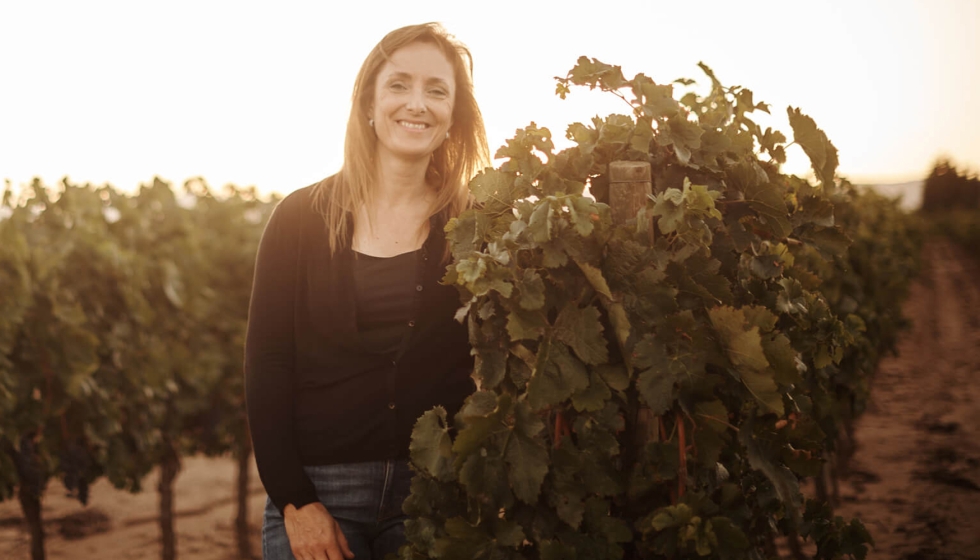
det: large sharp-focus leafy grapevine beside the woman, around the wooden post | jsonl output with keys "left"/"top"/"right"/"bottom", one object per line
{"left": 400, "top": 57, "right": 916, "bottom": 559}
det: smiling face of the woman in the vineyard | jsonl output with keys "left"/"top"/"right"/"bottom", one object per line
{"left": 370, "top": 43, "right": 456, "bottom": 164}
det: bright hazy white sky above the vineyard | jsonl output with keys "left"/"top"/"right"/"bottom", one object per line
{"left": 0, "top": 0, "right": 980, "bottom": 197}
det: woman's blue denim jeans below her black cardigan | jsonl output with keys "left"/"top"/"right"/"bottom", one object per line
{"left": 262, "top": 461, "right": 413, "bottom": 560}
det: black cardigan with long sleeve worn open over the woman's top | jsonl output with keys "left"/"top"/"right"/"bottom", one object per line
{"left": 245, "top": 185, "right": 474, "bottom": 511}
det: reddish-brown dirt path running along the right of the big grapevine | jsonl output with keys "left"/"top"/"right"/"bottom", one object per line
{"left": 838, "top": 241, "right": 980, "bottom": 560}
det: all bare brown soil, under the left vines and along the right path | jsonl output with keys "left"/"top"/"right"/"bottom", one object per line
{"left": 0, "top": 240, "right": 980, "bottom": 560}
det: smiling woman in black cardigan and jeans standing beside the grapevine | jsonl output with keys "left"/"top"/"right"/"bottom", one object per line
{"left": 245, "top": 24, "right": 489, "bottom": 560}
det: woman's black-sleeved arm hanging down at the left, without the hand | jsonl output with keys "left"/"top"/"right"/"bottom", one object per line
{"left": 245, "top": 196, "right": 318, "bottom": 512}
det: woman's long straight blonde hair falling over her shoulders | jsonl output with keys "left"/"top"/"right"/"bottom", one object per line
{"left": 312, "top": 23, "right": 490, "bottom": 254}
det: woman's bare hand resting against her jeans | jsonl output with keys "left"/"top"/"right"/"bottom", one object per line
{"left": 282, "top": 502, "right": 354, "bottom": 560}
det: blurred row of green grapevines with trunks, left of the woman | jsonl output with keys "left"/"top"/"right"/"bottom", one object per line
{"left": 0, "top": 179, "right": 276, "bottom": 560}
